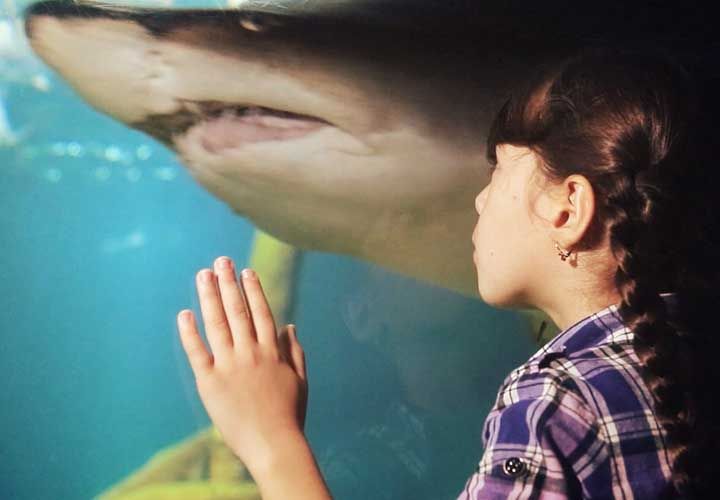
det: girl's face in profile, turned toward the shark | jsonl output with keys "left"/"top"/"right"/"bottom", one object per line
{"left": 472, "top": 144, "right": 552, "bottom": 307}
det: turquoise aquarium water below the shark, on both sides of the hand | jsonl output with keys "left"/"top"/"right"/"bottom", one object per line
{"left": 0, "top": 4, "right": 537, "bottom": 500}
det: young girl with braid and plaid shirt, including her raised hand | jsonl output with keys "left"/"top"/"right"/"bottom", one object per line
{"left": 173, "top": 49, "right": 720, "bottom": 500}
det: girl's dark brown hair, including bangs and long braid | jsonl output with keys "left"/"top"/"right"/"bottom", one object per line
{"left": 487, "top": 46, "right": 720, "bottom": 498}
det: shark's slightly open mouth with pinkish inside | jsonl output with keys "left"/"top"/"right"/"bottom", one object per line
{"left": 134, "top": 101, "right": 335, "bottom": 153}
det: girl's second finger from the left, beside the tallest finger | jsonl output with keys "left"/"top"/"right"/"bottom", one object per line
{"left": 197, "top": 269, "right": 233, "bottom": 363}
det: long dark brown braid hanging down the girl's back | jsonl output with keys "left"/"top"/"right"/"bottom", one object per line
{"left": 607, "top": 163, "right": 697, "bottom": 497}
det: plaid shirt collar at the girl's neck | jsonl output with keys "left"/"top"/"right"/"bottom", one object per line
{"left": 528, "top": 292, "right": 677, "bottom": 363}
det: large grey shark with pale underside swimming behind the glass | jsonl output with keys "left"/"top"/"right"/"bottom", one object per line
{"left": 24, "top": 0, "right": 710, "bottom": 297}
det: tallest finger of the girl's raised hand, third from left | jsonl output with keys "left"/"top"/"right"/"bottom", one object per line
{"left": 215, "top": 257, "right": 255, "bottom": 349}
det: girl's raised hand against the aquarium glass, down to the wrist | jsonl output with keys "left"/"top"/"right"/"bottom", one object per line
{"left": 177, "top": 257, "right": 308, "bottom": 473}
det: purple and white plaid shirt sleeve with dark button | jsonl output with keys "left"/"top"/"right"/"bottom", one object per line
{"left": 458, "top": 375, "right": 607, "bottom": 500}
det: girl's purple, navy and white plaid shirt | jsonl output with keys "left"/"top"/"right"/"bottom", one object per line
{"left": 458, "top": 293, "right": 676, "bottom": 500}
